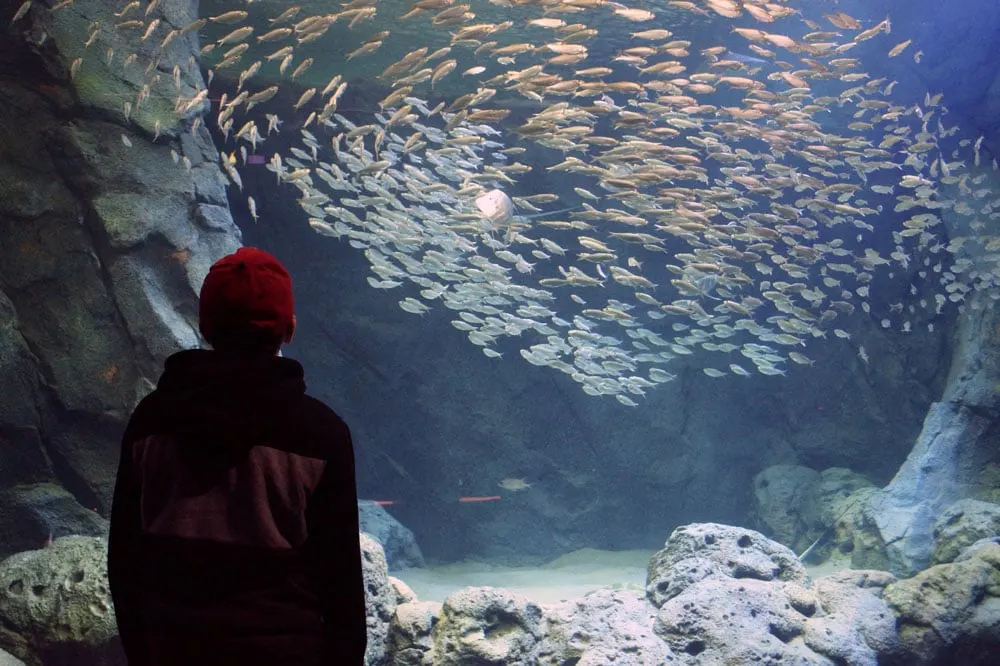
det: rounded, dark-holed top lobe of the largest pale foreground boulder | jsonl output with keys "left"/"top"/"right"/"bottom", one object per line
{"left": 646, "top": 523, "right": 809, "bottom": 608}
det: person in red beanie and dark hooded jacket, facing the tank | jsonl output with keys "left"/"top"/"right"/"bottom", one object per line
{"left": 108, "top": 247, "right": 367, "bottom": 666}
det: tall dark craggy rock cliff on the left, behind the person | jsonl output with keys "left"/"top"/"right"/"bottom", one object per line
{"left": 0, "top": 0, "right": 240, "bottom": 513}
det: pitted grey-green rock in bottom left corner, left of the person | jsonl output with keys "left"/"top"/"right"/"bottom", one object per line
{"left": 0, "top": 536, "right": 119, "bottom": 665}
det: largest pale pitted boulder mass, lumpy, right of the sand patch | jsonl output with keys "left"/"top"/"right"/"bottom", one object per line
{"left": 647, "top": 523, "right": 898, "bottom": 666}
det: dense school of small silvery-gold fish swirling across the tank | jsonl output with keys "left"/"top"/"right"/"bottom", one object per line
{"left": 13, "top": 0, "right": 1000, "bottom": 407}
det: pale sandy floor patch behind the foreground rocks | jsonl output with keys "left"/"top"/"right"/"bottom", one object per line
{"left": 393, "top": 548, "right": 850, "bottom": 604}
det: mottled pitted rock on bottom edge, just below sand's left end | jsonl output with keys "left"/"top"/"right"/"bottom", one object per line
{"left": 432, "top": 587, "right": 543, "bottom": 666}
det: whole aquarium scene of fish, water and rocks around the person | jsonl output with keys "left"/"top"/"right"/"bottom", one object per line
{"left": 0, "top": 0, "right": 1000, "bottom": 666}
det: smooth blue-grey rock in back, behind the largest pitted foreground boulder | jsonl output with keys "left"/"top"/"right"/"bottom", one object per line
{"left": 753, "top": 465, "right": 820, "bottom": 550}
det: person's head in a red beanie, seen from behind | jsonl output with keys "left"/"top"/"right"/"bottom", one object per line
{"left": 198, "top": 247, "right": 295, "bottom": 356}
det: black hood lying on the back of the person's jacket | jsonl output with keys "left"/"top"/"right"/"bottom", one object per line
{"left": 156, "top": 349, "right": 306, "bottom": 448}
